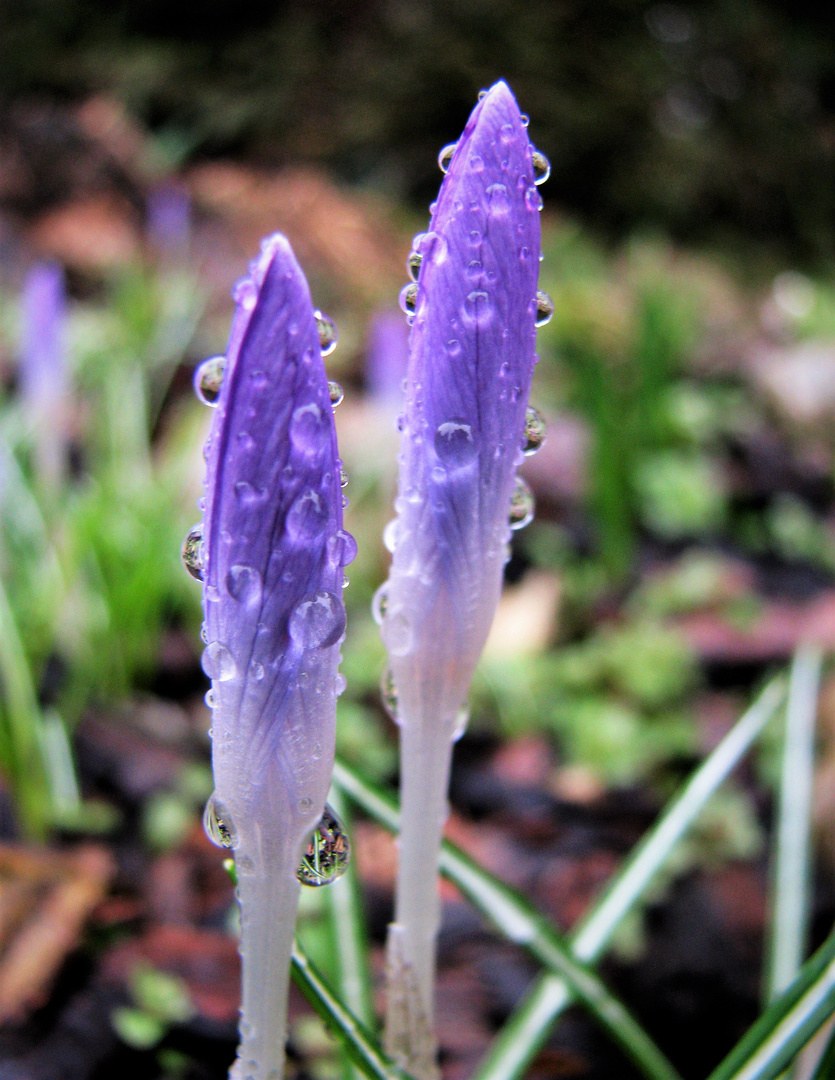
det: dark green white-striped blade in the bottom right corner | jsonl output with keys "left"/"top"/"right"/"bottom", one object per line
{"left": 709, "top": 933, "right": 835, "bottom": 1080}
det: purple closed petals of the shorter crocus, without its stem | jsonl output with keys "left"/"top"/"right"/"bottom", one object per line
{"left": 203, "top": 234, "right": 353, "bottom": 836}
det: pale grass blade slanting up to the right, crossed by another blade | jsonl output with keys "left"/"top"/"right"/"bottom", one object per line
{"left": 473, "top": 678, "right": 784, "bottom": 1080}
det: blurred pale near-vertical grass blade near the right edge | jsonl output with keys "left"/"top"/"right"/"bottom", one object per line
{"left": 766, "top": 647, "right": 823, "bottom": 1001}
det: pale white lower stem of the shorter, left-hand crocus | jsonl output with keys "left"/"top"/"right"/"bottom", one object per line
{"left": 229, "top": 849, "right": 300, "bottom": 1080}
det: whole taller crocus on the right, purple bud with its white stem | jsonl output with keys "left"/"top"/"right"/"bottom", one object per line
{"left": 376, "top": 82, "right": 544, "bottom": 1078}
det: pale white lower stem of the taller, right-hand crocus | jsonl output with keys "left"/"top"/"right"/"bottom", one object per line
{"left": 386, "top": 724, "right": 453, "bottom": 1080}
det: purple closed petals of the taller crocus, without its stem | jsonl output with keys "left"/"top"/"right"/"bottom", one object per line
{"left": 382, "top": 82, "right": 541, "bottom": 725}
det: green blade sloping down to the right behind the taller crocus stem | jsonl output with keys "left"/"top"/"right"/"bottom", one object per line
{"left": 334, "top": 764, "right": 677, "bottom": 1080}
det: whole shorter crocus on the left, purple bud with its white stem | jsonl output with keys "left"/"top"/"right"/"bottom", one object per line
{"left": 196, "top": 234, "right": 355, "bottom": 1080}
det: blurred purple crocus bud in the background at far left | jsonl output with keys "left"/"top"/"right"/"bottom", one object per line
{"left": 19, "top": 262, "right": 67, "bottom": 484}
